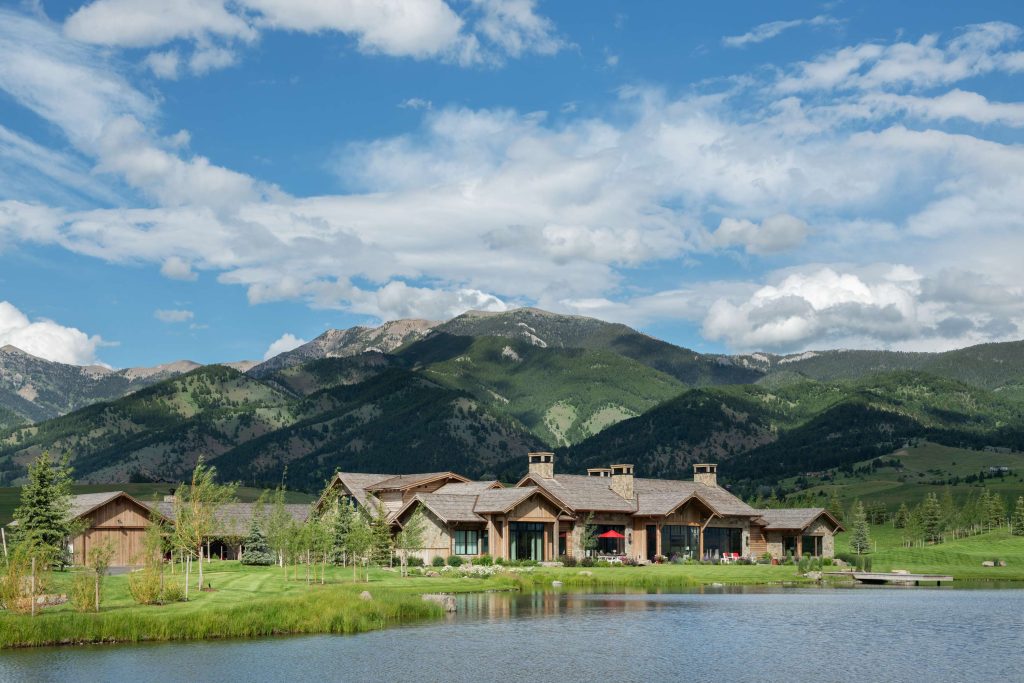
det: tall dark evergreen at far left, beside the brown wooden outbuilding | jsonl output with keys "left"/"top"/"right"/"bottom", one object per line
{"left": 14, "top": 453, "right": 78, "bottom": 565}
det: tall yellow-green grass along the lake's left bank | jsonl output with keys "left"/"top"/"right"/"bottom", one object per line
{"left": 0, "top": 587, "right": 443, "bottom": 648}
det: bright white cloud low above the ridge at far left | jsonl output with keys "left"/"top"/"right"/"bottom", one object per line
{"left": 0, "top": 301, "right": 103, "bottom": 366}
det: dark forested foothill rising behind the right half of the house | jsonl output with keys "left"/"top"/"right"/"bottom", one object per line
{"left": 562, "top": 372, "right": 1024, "bottom": 493}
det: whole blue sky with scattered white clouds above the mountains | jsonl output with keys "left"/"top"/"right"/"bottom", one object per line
{"left": 0, "top": 0, "right": 1024, "bottom": 368}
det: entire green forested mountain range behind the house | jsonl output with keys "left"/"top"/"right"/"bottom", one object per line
{"left": 0, "top": 308, "right": 1024, "bottom": 489}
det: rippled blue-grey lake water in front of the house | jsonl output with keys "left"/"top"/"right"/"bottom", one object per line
{"left": 0, "top": 588, "right": 1024, "bottom": 683}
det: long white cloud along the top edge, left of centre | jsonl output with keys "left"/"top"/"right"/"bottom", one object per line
{"left": 65, "top": 0, "right": 563, "bottom": 78}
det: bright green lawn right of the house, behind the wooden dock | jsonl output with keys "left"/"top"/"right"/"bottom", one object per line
{"left": 836, "top": 525, "right": 1024, "bottom": 581}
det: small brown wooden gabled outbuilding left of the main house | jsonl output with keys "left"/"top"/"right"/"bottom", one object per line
{"left": 70, "top": 490, "right": 167, "bottom": 566}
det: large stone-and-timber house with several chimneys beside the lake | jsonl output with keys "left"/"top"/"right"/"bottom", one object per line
{"left": 322, "top": 453, "right": 843, "bottom": 561}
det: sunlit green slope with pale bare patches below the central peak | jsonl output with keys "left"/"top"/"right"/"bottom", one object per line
{"left": 400, "top": 333, "right": 686, "bottom": 445}
